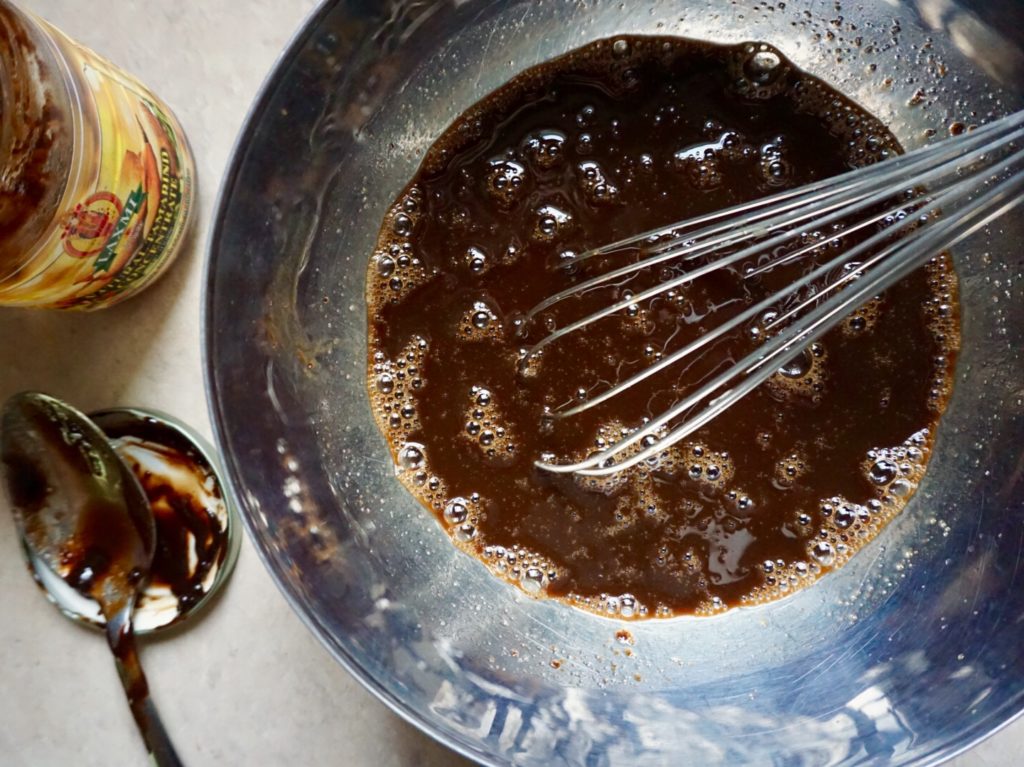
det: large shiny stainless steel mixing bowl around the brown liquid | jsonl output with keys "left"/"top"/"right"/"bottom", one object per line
{"left": 205, "top": 0, "right": 1024, "bottom": 766}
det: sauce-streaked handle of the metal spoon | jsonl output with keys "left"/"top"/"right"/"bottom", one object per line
{"left": 106, "top": 605, "right": 182, "bottom": 767}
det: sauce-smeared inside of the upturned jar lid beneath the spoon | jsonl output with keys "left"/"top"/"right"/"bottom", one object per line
{"left": 97, "top": 413, "right": 229, "bottom": 611}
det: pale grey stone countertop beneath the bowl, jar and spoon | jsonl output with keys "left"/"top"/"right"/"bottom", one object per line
{"left": 0, "top": 0, "right": 1024, "bottom": 767}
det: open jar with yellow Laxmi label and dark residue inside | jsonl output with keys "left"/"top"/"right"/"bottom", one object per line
{"left": 0, "top": 0, "right": 195, "bottom": 309}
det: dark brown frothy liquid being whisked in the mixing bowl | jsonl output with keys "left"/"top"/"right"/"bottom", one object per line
{"left": 368, "top": 38, "right": 958, "bottom": 617}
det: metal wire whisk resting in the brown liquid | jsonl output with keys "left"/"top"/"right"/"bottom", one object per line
{"left": 523, "top": 112, "right": 1024, "bottom": 476}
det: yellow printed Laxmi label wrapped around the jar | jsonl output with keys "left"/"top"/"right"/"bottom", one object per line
{"left": 0, "top": 20, "right": 194, "bottom": 309}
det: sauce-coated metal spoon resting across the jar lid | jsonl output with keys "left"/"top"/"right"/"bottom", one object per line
{"left": 0, "top": 392, "right": 181, "bottom": 767}
